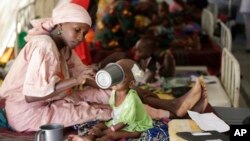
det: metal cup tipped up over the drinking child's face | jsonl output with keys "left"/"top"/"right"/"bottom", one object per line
{"left": 95, "top": 63, "right": 124, "bottom": 89}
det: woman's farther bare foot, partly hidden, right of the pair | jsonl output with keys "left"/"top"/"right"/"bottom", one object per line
{"left": 191, "top": 77, "right": 208, "bottom": 113}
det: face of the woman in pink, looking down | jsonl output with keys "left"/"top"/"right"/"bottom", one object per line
{"left": 61, "top": 23, "right": 90, "bottom": 49}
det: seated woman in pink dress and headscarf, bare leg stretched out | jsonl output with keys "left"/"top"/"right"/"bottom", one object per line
{"left": 0, "top": 3, "right": 207, "bottom": 132}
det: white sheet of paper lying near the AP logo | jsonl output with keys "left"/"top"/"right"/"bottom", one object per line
{"left": 188, "top": 111, "right": 230, "bottom": 133}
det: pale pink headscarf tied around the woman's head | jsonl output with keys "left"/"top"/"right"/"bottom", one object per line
{"left": 25, "top": 3, "right": 92, "bottom": 41}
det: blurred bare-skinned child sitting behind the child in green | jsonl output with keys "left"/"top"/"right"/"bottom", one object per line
{"left": 134, "top": 36, "right": 175, "bottom": 83}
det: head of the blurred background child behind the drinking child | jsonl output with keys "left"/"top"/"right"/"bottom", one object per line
{"left": 135, "top": 36, "right": 157, "bottom": 60}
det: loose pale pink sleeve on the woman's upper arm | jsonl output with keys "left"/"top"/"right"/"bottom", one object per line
{"left": 23, "top": 43, "right": 60, "bottom": 97}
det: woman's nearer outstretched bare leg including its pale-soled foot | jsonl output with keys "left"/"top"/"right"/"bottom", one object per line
{"left": 136, "top": 79, "right": 202, "bottom": 117}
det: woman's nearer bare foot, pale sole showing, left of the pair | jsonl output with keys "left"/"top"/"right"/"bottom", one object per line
{"left": 175, "top": 78, "right": 202, "bottom": 117}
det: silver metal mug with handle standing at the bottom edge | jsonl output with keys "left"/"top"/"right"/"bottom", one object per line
{"left": 36, "top": 124, "right": 63, "bottom": 141}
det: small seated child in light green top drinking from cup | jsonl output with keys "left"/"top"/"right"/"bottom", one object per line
{"left": 69, "top": 59, "right": 153, "bottom": 141}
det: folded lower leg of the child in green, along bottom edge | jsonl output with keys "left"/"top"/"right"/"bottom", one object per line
{"left": 96, "top": 131, "right": 141, "bottom": 141}
